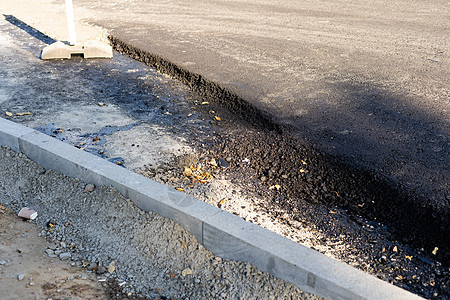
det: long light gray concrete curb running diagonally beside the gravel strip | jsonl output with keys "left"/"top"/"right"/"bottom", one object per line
{"left": 0, "top": 118, "right": 422, "bottom": 299}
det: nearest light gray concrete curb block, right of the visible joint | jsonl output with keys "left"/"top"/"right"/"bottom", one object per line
{"left": 203, "top": 212, "right": 421, "bottom": 299}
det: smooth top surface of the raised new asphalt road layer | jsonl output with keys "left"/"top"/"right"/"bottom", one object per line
{"left": 76, "top": 0, "right": 450, "bottom": 211}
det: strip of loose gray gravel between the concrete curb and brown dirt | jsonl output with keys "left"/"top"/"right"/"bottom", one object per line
{"left": 0, "top": 147, "right": 316, "bottom": 299}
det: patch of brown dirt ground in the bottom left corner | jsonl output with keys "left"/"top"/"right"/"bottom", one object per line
{"left": 0, "top": 206, "right": 108, "bottom": 300}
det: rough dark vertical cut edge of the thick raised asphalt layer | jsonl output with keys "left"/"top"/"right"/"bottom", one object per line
{"left": 108, "top": 32, "right": 449, "bottom": 262}
